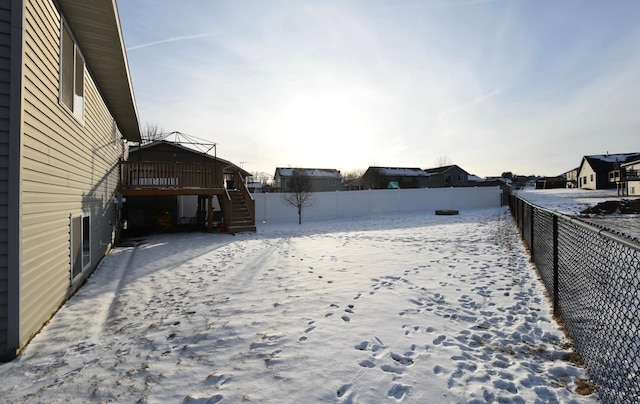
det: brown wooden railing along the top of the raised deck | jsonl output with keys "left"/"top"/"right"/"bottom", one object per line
{"left": 120, "top": 161, "right": 223, "bottom": 190}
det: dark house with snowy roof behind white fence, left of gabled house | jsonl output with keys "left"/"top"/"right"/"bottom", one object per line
{"left": 362, "top": 167, "right": 429, "bottom": 189}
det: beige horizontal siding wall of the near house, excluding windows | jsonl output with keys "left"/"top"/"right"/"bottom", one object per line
{"left": 16, "top": 0, "right": 126, "bottom": 354}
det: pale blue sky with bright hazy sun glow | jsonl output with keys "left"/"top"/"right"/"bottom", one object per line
{"left": 118, "top": 0, "right": 640, "bottom": 177}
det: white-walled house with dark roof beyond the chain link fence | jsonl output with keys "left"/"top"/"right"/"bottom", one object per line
{"left": 578, "top": 153, "right": 640, "bottom": 189}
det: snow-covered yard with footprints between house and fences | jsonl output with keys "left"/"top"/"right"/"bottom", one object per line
{"left": 0, "top": 208, "right": 597, "bottom": 403}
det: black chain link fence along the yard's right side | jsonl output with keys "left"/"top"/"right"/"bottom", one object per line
{"left": 510, "top": 195, "right": 640, "bottom": 403}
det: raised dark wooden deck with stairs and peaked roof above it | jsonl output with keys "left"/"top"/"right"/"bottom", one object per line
{"left": 120, "top": 140, "right": 256, "bottom": 233}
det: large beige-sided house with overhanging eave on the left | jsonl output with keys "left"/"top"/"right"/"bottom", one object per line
{"left": 0, "top": 0, "right": 140, "bottom": 360}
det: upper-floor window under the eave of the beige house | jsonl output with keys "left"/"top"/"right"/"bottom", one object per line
{"left": 60, "top": 24, "right": 84, "bottom": 119}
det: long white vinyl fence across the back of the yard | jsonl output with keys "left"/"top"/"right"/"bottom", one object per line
{"left": 253, "top": 186, "right": 502, "bottom": 223}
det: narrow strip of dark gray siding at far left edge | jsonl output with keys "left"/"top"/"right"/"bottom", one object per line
{"left": 0, "top": 2, "right": 11, "bottom": 357}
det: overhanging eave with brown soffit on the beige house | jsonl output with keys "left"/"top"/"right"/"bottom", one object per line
{"left": 58, "top": 0, "right": 140, "bottom": 142}
